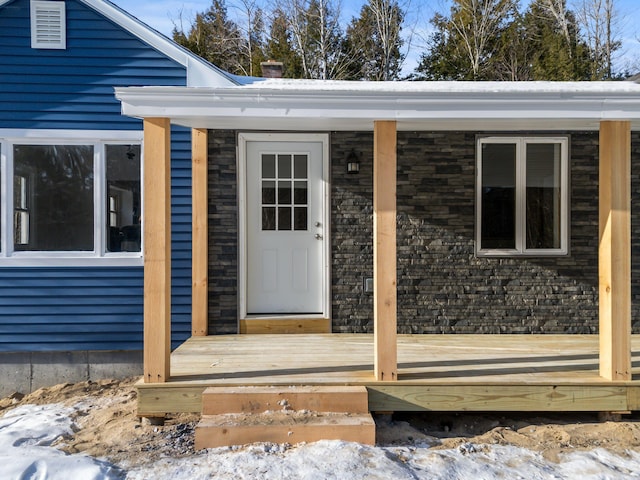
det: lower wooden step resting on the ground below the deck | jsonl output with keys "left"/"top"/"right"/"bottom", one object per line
{"left": 195, "top": 412, "right": 376, "bottom": 450}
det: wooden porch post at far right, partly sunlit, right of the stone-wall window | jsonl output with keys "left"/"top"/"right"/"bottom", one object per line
{"left": 599, "top": 121, "right": 631, "bottom": 381}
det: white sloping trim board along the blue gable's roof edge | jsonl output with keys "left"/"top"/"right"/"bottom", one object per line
{"left": 81, "top": 0, "right": 237, "bottom": 87}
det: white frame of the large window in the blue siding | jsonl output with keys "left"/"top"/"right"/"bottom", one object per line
{"left": 0, "top": 129, "right": 144, "bottom": 268}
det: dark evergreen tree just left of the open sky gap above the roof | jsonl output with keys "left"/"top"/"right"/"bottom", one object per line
{"left": 346, "top": 0, "right": 404, "bottom": 80}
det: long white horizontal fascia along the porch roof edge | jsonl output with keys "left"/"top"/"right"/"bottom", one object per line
{"left": 116, "top": 87, "right": 640, "bottom": 130}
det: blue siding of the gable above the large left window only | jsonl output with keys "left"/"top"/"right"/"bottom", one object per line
{"left": 0, "top": 0, "right": 186, "bottom": 130}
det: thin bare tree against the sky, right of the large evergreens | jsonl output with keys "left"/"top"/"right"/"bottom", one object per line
{"left": 577, "top": 0, "right": 621, "bottom": 80}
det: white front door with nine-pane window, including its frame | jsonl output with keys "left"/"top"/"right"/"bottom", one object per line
{"left": 241, "top": 134, "right": 328, "bottom": 316}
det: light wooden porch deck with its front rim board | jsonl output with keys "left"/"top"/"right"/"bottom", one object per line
{"left": 137, "top": 334, "right": 640, "bottom": 416}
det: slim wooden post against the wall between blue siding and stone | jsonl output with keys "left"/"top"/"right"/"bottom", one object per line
{"left": 191, "top": 128, "right": 209, "bottom": 336}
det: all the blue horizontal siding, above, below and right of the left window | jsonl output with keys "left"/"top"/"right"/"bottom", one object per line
{"left": 0, "top": 0, "right": 191, "bottom": 352}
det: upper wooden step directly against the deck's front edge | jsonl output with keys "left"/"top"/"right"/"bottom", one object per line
{"left": 202, "top": 386, "right": 369, "bottom": 415}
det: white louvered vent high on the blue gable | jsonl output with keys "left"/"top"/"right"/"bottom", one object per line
{"left": 31, "top": 0, "right": 67, "bottom": 49}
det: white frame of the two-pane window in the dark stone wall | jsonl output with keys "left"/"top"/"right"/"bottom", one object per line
{"left": 475, "top": 136, "right": 569, "bottom": 257}
